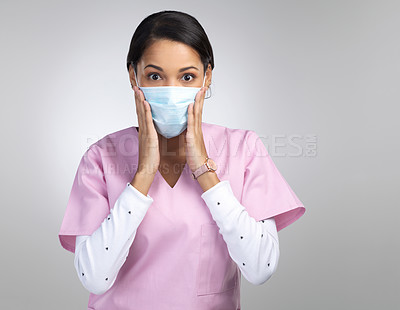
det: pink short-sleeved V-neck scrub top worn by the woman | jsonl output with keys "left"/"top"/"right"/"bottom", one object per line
{"left": 59, "top": 122, "right": 305, "bottom": 310}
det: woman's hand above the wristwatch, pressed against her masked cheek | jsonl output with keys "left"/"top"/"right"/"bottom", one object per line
{"left": 185, "top": 87, "right": 208, "bottom": 172}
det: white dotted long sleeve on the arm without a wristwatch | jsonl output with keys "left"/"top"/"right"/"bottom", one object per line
{"left": 74, "top": 183, "right": 153, "bottom": 295}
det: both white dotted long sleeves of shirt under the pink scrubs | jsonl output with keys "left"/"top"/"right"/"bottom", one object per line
{"left": 74, "top": 180, "right": 279, "bottom": 295}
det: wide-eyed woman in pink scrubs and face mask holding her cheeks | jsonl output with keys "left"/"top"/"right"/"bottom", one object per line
{"left": 59, "top": 11, "right": 305, "bottom": 310}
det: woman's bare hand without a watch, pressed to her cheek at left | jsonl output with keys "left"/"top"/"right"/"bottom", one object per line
{"left": 131, "top": 86, "right": 160, "bottom": 195}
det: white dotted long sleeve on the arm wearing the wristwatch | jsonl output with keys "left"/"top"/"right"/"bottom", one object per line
{"left": 201, "top": 180, "right": 280, "bottom": 285}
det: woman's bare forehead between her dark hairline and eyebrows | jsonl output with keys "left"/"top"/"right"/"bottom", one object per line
{"left": 140, "top": 39, "right": 201, "bottom": 68}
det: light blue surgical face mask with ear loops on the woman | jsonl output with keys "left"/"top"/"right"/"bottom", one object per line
{"left": 135, "top": 72, "right": 206, "bottom": 139}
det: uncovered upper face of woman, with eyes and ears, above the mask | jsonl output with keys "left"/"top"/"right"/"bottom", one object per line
{"left": 129, "top": 39, "right": 212, "bottom": 87}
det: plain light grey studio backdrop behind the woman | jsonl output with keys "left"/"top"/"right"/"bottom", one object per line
{"left": 0, "top": 0, "right": 400, "bottom": 310}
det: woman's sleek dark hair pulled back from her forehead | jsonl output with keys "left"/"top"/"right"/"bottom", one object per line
{"left": 126, "top": 11, "right": 214, "bottom": 72}
